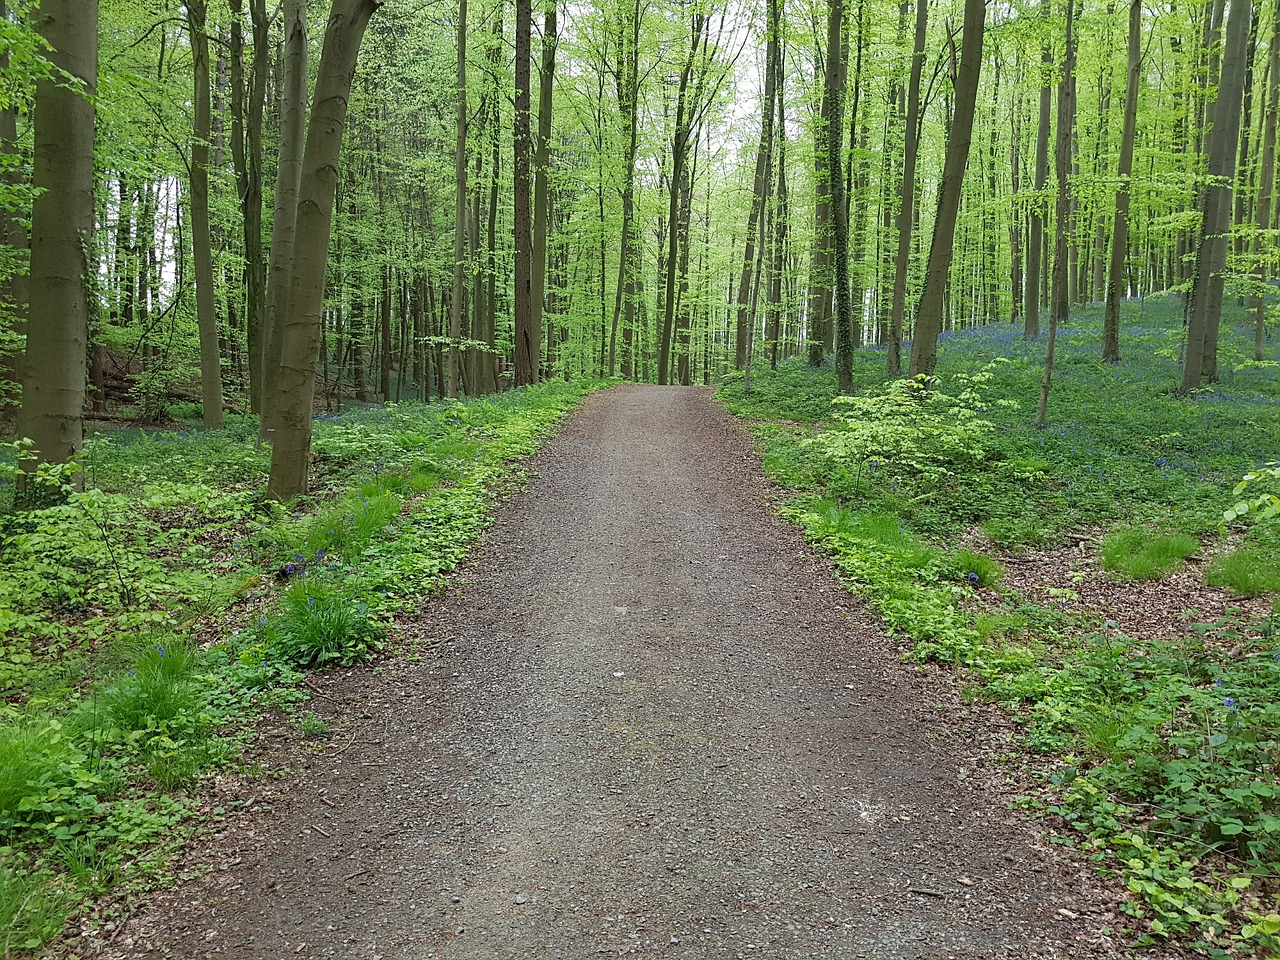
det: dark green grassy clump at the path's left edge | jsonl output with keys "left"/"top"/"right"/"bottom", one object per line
{"left": 259, "top": 575, "right": 384, "bottom": 667}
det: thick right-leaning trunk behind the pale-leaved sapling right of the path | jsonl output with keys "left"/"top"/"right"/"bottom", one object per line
{"left": 910, "top": 0, "right": 987, "bottom": 378}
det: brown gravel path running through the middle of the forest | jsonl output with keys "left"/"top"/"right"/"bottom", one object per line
{"left": 108, "top": 387, "right": 1131, "bottom": 960}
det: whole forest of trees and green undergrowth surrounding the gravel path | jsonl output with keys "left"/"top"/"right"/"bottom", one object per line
{"left": 0, "top": 0, "right": 1280, "bottom": 957}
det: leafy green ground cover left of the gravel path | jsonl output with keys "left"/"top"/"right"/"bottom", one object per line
{"left": 0, "top": 383, "right": 599, "bottom": 956}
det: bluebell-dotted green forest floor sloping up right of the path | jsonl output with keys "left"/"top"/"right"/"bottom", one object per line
{"left": 719, "top": 301, "right": 1280, "bottom": 956}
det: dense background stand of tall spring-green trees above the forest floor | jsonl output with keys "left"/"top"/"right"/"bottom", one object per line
{"left": 0, "top": 0, "right": 1280, "bottom": 495}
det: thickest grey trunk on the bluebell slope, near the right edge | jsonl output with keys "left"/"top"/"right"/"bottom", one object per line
{"left": 1178, "top": 0, "right": 1252, "bottom": 394}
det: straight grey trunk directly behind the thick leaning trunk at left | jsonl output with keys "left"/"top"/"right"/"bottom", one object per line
{"left": 259, "top": 0, "right": 307, "bottom": 443}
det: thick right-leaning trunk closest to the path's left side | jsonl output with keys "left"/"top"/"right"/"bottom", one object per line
{"left": 266, "top": 0, "right": 379, "bottom": 499}
